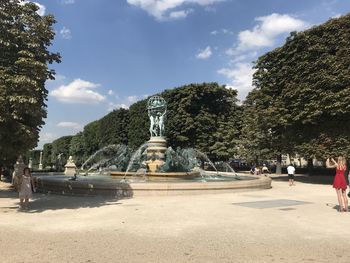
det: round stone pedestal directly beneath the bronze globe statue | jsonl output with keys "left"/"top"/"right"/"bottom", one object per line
{"left": 146, "top": 136, "right": 167, "bottom": 173}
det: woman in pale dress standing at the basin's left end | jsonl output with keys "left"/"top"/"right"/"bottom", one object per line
{"left": 18, "top": 167, "right": 35, "bottom": 209}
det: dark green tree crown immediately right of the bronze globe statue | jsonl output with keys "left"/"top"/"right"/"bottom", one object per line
{"left": 160, "top": 83, "right": 240, "bottom": 160}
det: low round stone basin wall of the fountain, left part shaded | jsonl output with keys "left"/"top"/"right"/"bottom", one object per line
{"left": 33, "top": 172, "right": 271, "bottom": 198}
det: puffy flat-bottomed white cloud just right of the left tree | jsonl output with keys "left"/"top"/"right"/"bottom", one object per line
{"left": 50, "top": 79, "right": 106, "bottom": 104}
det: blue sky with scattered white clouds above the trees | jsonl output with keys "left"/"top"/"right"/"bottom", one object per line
{"left": 33, "top": 0, "right": 350, "bottom": 149}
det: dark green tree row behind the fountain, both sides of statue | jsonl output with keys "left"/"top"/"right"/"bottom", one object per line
{"left": 44, "top": 83, "right": 242, "bottom": 166}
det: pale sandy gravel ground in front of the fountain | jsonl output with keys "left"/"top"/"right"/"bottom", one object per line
{"left": 0, "top": 176, "right": 350, "bottom": 263}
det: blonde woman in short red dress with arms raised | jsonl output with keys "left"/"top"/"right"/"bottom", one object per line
{"left": 326, "top": 156, "right": 348, "bottom": 212}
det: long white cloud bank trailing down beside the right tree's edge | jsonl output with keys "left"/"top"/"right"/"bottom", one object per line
{"left": 219, "top": 13, "right": 309, "bottom": 100}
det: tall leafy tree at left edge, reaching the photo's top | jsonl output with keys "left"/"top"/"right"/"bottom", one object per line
{"left": 0, "top": 0, "right": 60, "bottom": 165}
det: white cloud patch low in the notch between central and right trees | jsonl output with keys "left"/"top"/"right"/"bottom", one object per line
{"left": 218, "top": 63, "right": 254, "bottom": 99}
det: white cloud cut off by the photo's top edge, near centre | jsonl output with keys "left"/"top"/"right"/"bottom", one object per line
{"left": 127, "top": 0, "right": 226, "bottom": 21}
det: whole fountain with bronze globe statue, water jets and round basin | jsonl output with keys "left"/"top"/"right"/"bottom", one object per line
{"left": 36, "top": 96, "right": 271, "bottom": 197}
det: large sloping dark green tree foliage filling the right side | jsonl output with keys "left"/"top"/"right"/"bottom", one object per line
{"left": 242, "top": 15, "right": 350, "bottom": 163}
